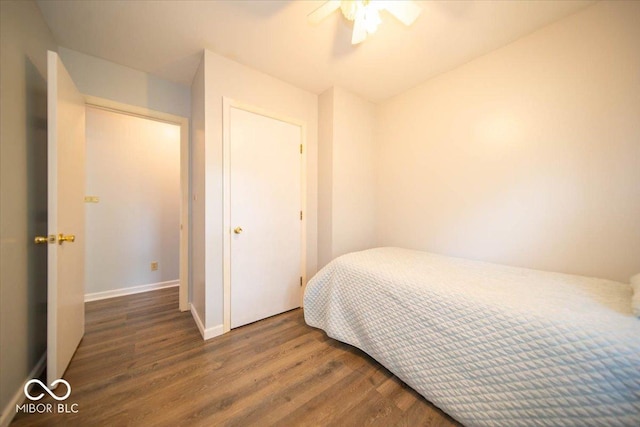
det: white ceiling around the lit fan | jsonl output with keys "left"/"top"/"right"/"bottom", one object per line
{"left": 37, "top": 0, "right": 593, "bottom": 101}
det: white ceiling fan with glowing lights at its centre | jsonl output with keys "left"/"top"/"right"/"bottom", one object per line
{"left": 307, "top": 0, "right": 422, "bottom": 44}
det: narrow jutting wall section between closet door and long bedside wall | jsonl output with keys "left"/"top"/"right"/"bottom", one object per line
{"left": 318, "top": 87, "right": 376, "bottom": 267}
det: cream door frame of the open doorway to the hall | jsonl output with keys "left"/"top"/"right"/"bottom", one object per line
{"left": 84, "top": 95, "right": 192, "bottom": 311}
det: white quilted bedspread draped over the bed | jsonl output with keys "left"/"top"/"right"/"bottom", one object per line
{"left": 304, "top": 248, "right": 640, "bottom": 427}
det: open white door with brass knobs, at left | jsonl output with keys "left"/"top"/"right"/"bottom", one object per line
{"left": 47, "top": 52, "right": 85, "bottom": 384}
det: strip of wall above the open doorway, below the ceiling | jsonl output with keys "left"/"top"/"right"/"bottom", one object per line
{"left": 59, "top": 47, "right": 191, "bottom": 117}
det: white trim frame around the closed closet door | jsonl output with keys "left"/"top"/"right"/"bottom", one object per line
{"left": 222, "top": 96, "right": 308, "bottom": 333}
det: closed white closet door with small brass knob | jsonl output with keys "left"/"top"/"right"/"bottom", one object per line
{"left": 229, "top": 107, "right": 302, "bottom": 328}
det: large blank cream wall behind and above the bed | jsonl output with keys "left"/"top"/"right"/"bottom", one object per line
{"left": 377, "top": 2, "right": 640, "bottom": 281}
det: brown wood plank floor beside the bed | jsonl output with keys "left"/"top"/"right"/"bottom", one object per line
{"left": 12, "top": 288, "right": 459, "bottom": 426}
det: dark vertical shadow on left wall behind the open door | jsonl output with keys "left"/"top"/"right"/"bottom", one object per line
{"left": 24, "top": 58, "right": 47, "bottom": 366}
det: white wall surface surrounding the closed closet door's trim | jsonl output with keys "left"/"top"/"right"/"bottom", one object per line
{"left": 193, "top": 51, "right": 318, "bottom": 329}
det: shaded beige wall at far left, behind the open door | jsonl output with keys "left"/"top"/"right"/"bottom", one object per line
{"left": 0, "top": 0, "right": 56, "bottom": 425}
